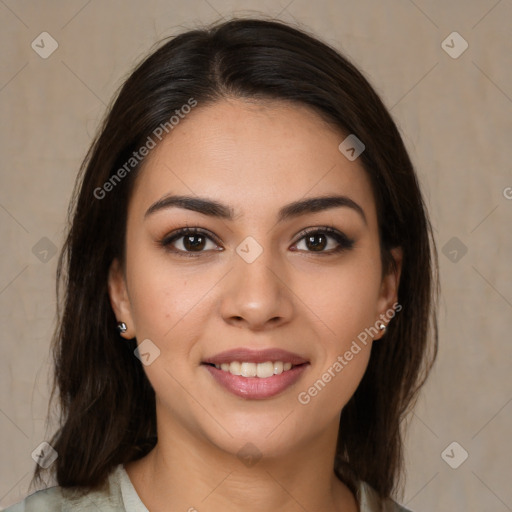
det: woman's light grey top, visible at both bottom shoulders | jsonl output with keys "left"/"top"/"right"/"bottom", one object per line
{"left": 5, "top": 464, "right": 410, "bottom": 512}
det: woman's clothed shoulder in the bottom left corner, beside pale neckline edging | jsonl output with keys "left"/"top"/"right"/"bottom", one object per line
{"left": 4, "top": 469, "right": 125, "bottom": 512}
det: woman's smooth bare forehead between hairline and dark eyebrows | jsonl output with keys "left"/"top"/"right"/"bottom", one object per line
{"left": 131, "top": 99, "right": 375, "bottom": 223}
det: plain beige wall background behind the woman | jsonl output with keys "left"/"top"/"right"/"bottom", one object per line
{"left": 0, "top": 0, "right": 512, "bottom": 512}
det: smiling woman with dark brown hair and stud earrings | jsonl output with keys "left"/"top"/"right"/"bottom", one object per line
{"left": 8, "top": 19, "right": 437, "bottom": 512}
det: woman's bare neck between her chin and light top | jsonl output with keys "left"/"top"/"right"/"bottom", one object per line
{"left": 126, "top": 412, "right": 357, "bottom": 512}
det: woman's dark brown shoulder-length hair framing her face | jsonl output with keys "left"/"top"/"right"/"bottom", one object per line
{"left": 32, "top": 15, "right": 438, "bottom": 497}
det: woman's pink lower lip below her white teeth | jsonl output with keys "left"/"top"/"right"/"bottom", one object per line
{"left": 203, "top": 363, "right": 309, "bottom": 400}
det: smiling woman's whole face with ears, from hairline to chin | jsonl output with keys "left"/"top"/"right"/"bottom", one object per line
{"left": 109, "top": 100, "right": 400, "bottom": 456}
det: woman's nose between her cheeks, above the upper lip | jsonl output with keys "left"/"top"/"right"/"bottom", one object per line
{"left": 220, "top": 245, "right": 294, "bottom": 331}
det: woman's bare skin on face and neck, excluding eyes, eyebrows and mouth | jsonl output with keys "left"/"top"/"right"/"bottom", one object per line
{"left": 109, "top": 99, "right": 401, "bottom": 512}
